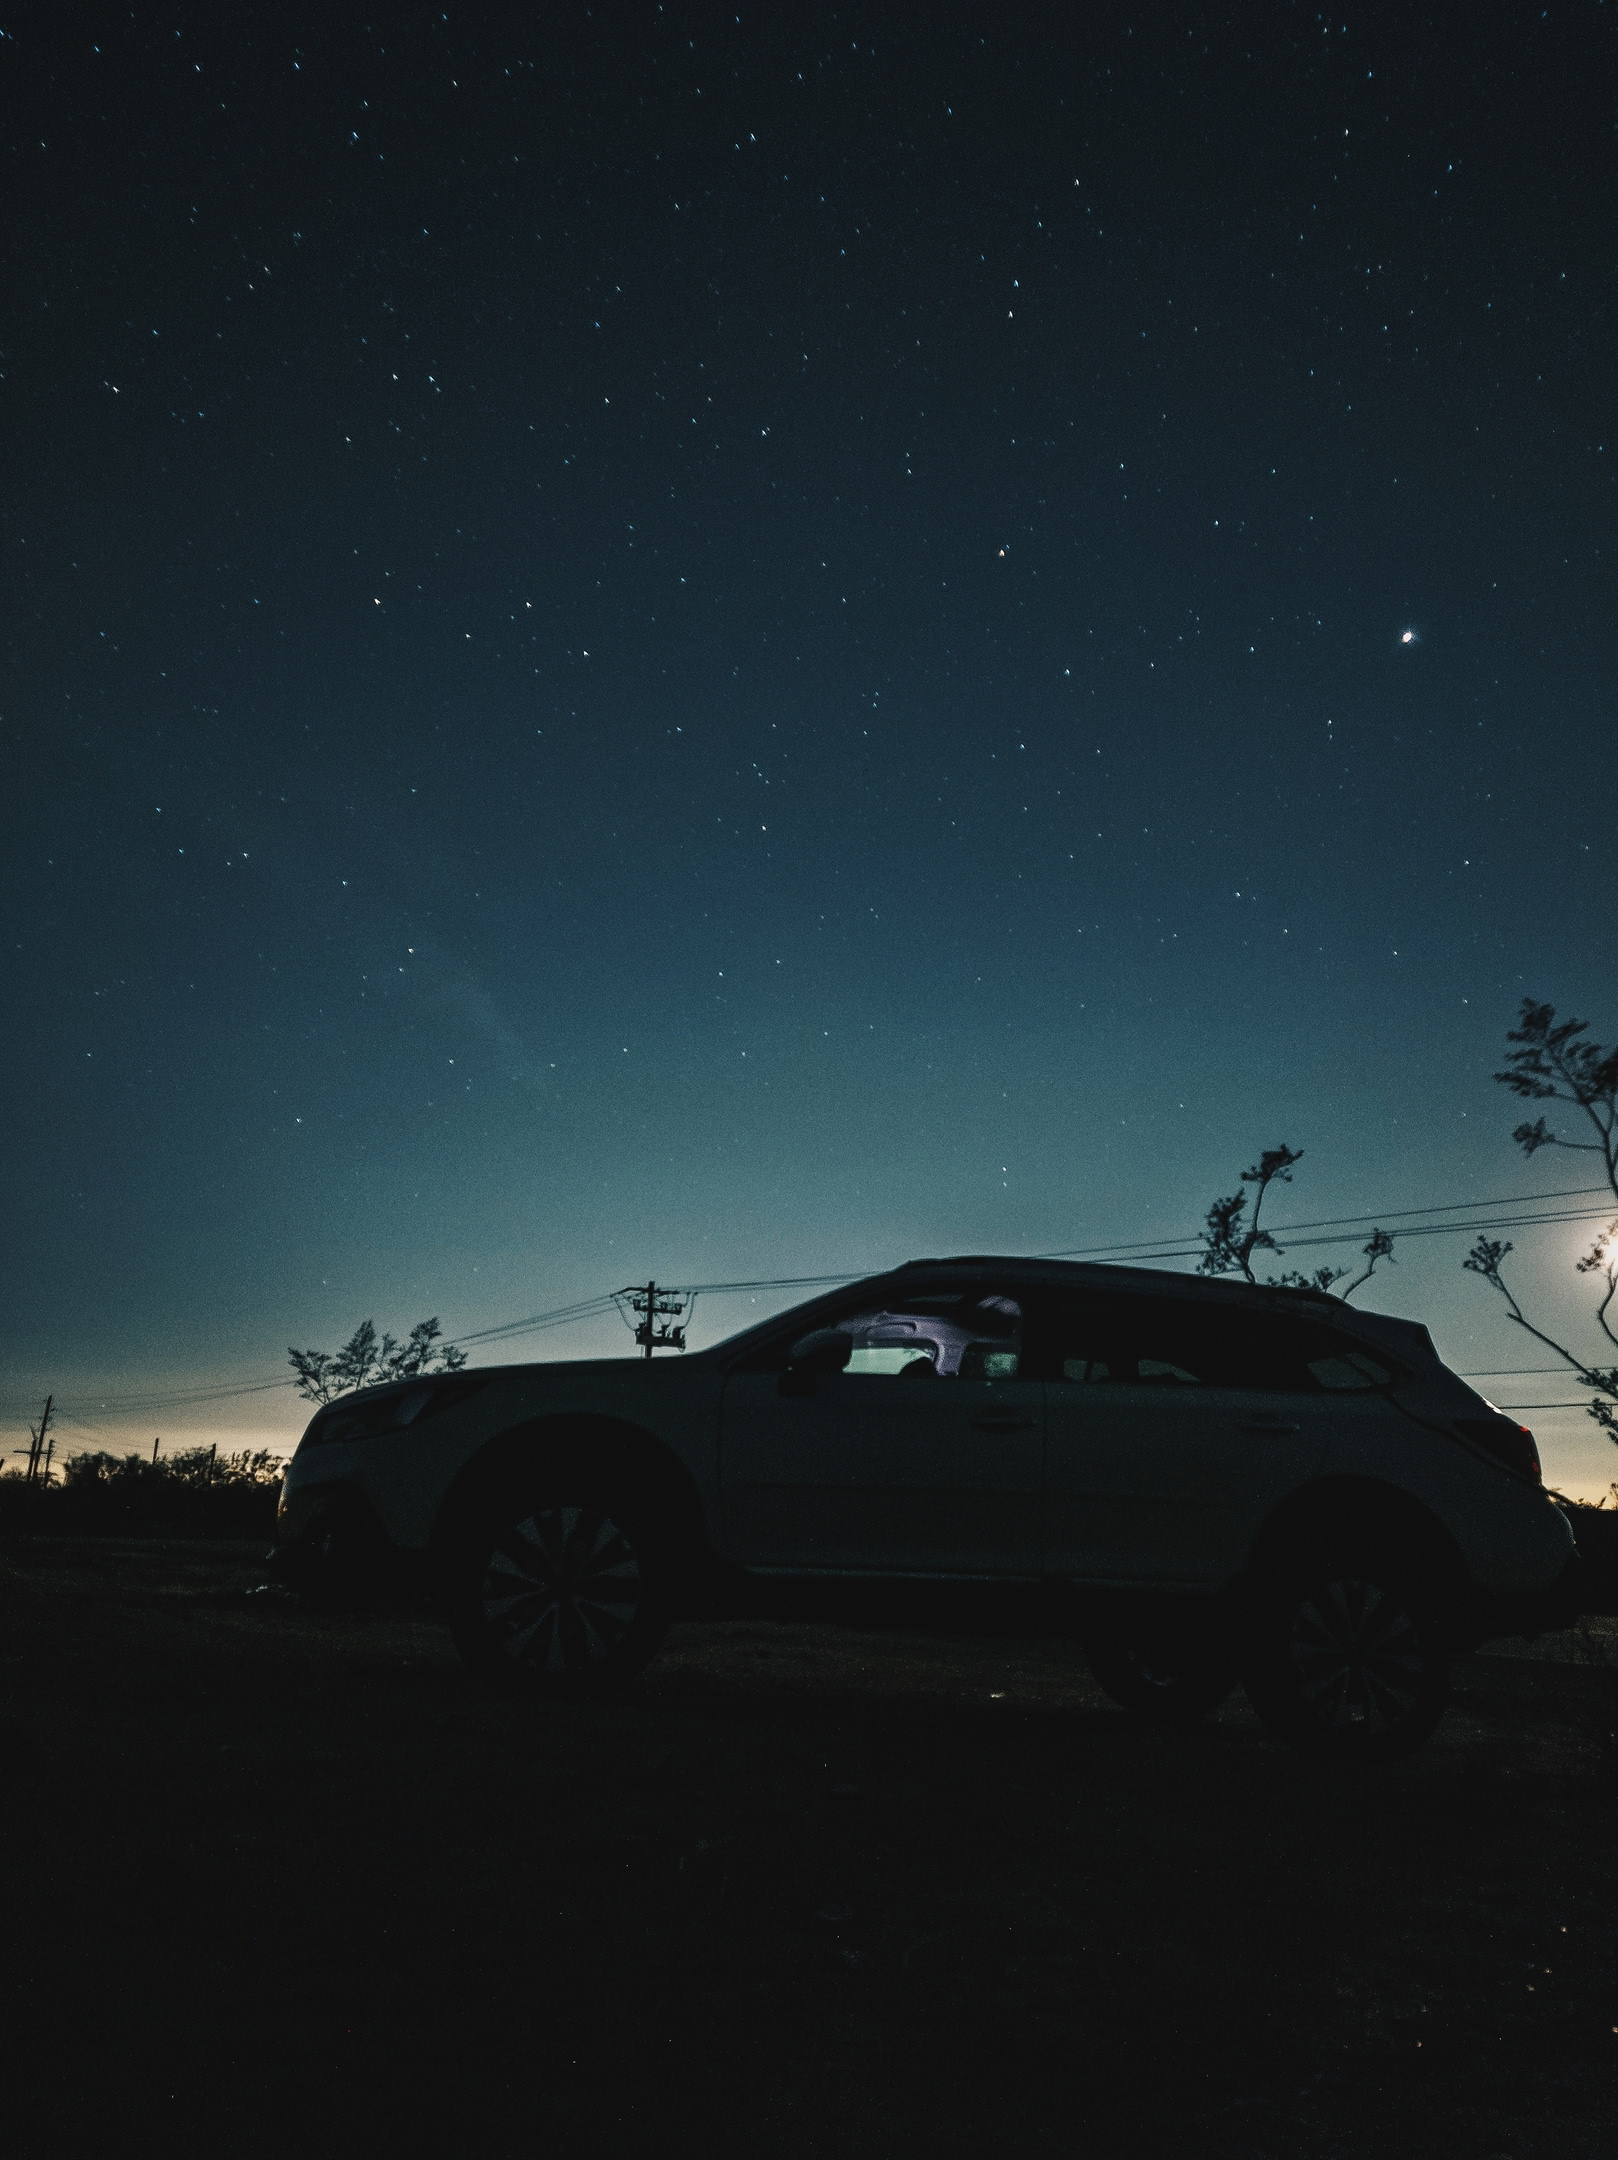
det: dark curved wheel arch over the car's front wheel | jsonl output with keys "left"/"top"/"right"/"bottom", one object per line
{"left": 430, "top": 1413, "right": 711, "bottom": 1577}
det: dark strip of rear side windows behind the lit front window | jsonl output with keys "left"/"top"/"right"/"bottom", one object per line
{"left": 1024, "top": 1298, "right": 1391, "bottom": 1395}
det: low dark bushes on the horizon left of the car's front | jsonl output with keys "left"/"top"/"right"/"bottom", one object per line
{"left": 0, "top": 1447, "right": 285, "bottom": 1542}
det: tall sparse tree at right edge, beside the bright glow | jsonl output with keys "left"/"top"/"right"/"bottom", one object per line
{"left": 1462, "top": 998, "right": 1618, "bottom": 1445}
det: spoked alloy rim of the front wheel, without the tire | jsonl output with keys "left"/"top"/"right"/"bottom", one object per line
{"left": 482, "top": 1508, "right": 644, "bottom": 1674}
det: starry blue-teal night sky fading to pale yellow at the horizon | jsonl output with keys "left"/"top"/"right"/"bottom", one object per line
{"left": 0, "top": 16, "right": 1618, "bottom": 1490}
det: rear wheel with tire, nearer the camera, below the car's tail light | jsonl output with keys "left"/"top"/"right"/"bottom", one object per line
{"left": 1244, "top": 1531, "right": 1450, "bottom": 1763}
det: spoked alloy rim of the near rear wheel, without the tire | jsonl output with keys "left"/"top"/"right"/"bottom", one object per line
{"left": 1285, "top": 1577, "right": 1428, "bottom": 1737}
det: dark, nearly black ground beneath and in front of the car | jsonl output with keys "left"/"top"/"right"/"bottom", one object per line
{"left": 0, "top": 1540, "right": 1618, "bottom": 2160}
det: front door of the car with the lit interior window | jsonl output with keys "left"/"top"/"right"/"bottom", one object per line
{"left": 719, "top": 1285, "right": 1043, "bottom": 1579}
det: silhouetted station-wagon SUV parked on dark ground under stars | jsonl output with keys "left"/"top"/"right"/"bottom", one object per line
{"left": 279, "top": 1257, "right": 1577, "bottom": 1758}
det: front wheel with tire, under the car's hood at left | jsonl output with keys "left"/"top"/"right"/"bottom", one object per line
{"left": 449, "top": 1471, "right": 668, "bottom": 1700}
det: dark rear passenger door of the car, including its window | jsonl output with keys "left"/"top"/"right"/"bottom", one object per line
{"left": 1041, "top": 1298, "right": 1329, "bottom": 1588}
